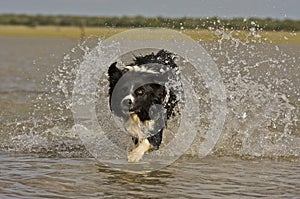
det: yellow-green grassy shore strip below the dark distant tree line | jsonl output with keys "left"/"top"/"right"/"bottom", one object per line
{"left": 0, "top": 25, "right": 300, "bottom": 44}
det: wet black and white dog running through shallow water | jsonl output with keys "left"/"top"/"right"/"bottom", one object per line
{"left": 108, "top": 50, "right": 179, "bottom": 162}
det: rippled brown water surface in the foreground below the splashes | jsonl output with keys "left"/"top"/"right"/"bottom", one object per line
{"left": 0, "top": 154, "right": 300, "bottom": 198}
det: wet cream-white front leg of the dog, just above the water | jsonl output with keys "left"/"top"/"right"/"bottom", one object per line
{"left": 128, "top": 139, "right": 152, "bottom": 162}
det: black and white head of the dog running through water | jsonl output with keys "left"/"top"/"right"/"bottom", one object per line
{"left": 109, "top": 63, "right": 167, "bottom": 122}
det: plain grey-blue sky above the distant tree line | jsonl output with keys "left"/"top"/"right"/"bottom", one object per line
{"left": 0, "top": 0, "right": 300, "bottom": 20}
